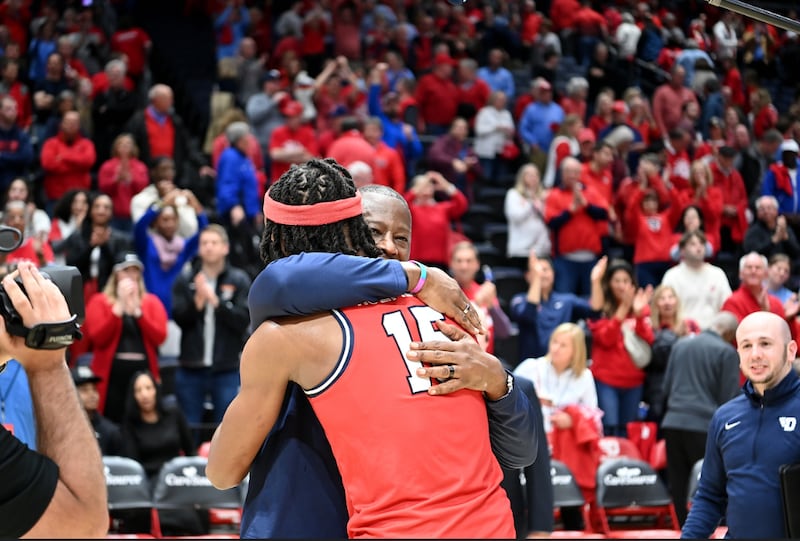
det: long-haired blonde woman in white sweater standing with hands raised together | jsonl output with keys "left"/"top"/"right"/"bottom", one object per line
{"left": 503, "top": 163, "right": 550, "bottom": 269}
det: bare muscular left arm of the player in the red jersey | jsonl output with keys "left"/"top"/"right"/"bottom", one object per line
{"left": 206, "top": 322, "right": 293, "bottom": 489}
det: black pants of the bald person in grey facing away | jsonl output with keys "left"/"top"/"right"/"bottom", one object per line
{"left": 664, "top": 428, "right": 708, "bottom": 526}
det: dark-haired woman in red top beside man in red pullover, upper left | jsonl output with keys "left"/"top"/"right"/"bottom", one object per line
{"left": 97, "top": 133, "right": 150, "bottom": 231}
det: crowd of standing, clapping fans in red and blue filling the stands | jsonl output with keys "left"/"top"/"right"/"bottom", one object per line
{"left": 0, "top": 0, "right": 800, "bottom": 532}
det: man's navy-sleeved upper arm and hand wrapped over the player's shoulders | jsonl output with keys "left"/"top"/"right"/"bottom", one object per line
{"left": 248, "top": 252, "right": 481, "bottom": 333}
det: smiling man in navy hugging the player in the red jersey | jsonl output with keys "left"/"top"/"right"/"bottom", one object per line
{"left": 236, "top": 185, "right": 536, "bottom": 539}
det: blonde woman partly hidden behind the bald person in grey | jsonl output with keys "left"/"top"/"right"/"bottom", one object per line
{"left": 642, "top": 284, "right": 700, "bottom": 425}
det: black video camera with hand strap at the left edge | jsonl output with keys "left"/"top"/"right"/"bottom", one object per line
{"left": 0, "top": 225, "right": 86, "bottom": 349}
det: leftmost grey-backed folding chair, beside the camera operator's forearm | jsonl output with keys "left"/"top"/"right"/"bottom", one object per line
{"left": 103, "top": 456, "right": 153, "bottom": 539}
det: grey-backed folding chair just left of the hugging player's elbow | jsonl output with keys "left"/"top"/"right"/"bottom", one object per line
{"left": 153, "top": 456, "right": 242, "bottom": 538}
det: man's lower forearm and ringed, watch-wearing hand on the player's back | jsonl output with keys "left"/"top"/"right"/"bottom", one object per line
{"left": 406, "top": 321, "right": 539, "bottom": 468}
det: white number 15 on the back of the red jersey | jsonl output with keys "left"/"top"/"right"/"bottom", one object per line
{"left": 383, "top": 306, "right": 448, "bottom": 394}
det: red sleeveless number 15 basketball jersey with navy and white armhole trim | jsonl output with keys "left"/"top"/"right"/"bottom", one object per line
{"left": 306, "top": 297, "right": 515, "bottom": 538}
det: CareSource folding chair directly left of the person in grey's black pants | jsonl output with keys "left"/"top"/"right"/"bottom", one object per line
{"left": 597, "top": 457, "right": 680, "bottom": 538}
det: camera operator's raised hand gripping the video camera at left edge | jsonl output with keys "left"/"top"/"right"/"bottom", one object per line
{"left": 0, "top": 261, "right": 72, "bottom": 364}
